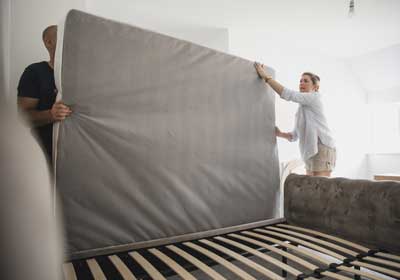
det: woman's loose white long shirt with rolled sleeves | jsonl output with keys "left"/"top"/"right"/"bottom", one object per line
{"left": 281, "top": 88, "right": 335, "bottom": 160}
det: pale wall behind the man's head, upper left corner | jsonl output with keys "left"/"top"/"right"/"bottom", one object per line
{"left": 8, "top": 0, "right": 84, "bottom": 103}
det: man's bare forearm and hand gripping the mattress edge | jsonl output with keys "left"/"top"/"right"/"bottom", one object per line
{"left": 17, "top": 97, "right": 72, "bottom": 126}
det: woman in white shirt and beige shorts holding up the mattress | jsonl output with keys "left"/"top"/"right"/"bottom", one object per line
{"left": 254, "top": 62, "right": 336, "bottom": 177}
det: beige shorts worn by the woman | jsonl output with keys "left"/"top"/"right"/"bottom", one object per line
{"left": 305, "top": 139, "right": 336, "bottom": 172}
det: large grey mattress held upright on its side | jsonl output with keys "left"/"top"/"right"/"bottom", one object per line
{"left": 56, "top": 10, "right": 279, "bottom": 253}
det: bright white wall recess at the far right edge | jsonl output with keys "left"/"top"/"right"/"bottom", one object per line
{"left": 349, "top": 44, "right": 400, "bottom": 179}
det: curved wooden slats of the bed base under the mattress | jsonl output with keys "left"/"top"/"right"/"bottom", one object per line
{"left": 63, "top": 223, "right": 400, "bottom": 280}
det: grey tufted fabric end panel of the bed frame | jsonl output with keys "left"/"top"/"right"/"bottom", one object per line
{"left": 284, "top": 174, "right": 400, "bottom": 252}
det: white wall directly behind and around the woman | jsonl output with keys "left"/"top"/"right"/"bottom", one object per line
{"left": 230, "top": 29, "right": 368, "bottom": 178}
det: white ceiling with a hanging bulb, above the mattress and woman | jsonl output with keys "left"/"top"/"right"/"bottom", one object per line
{"left": 86, "top": 0, "right": 400, "bottom": 57}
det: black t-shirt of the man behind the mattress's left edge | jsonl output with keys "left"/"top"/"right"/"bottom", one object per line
{"left": 18, "top": 61, "right": 57, "bottom": 161}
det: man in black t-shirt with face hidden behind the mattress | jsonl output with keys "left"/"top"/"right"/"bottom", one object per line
{"left": 18, "top": 25, "right": 72, "bottom": 163}
